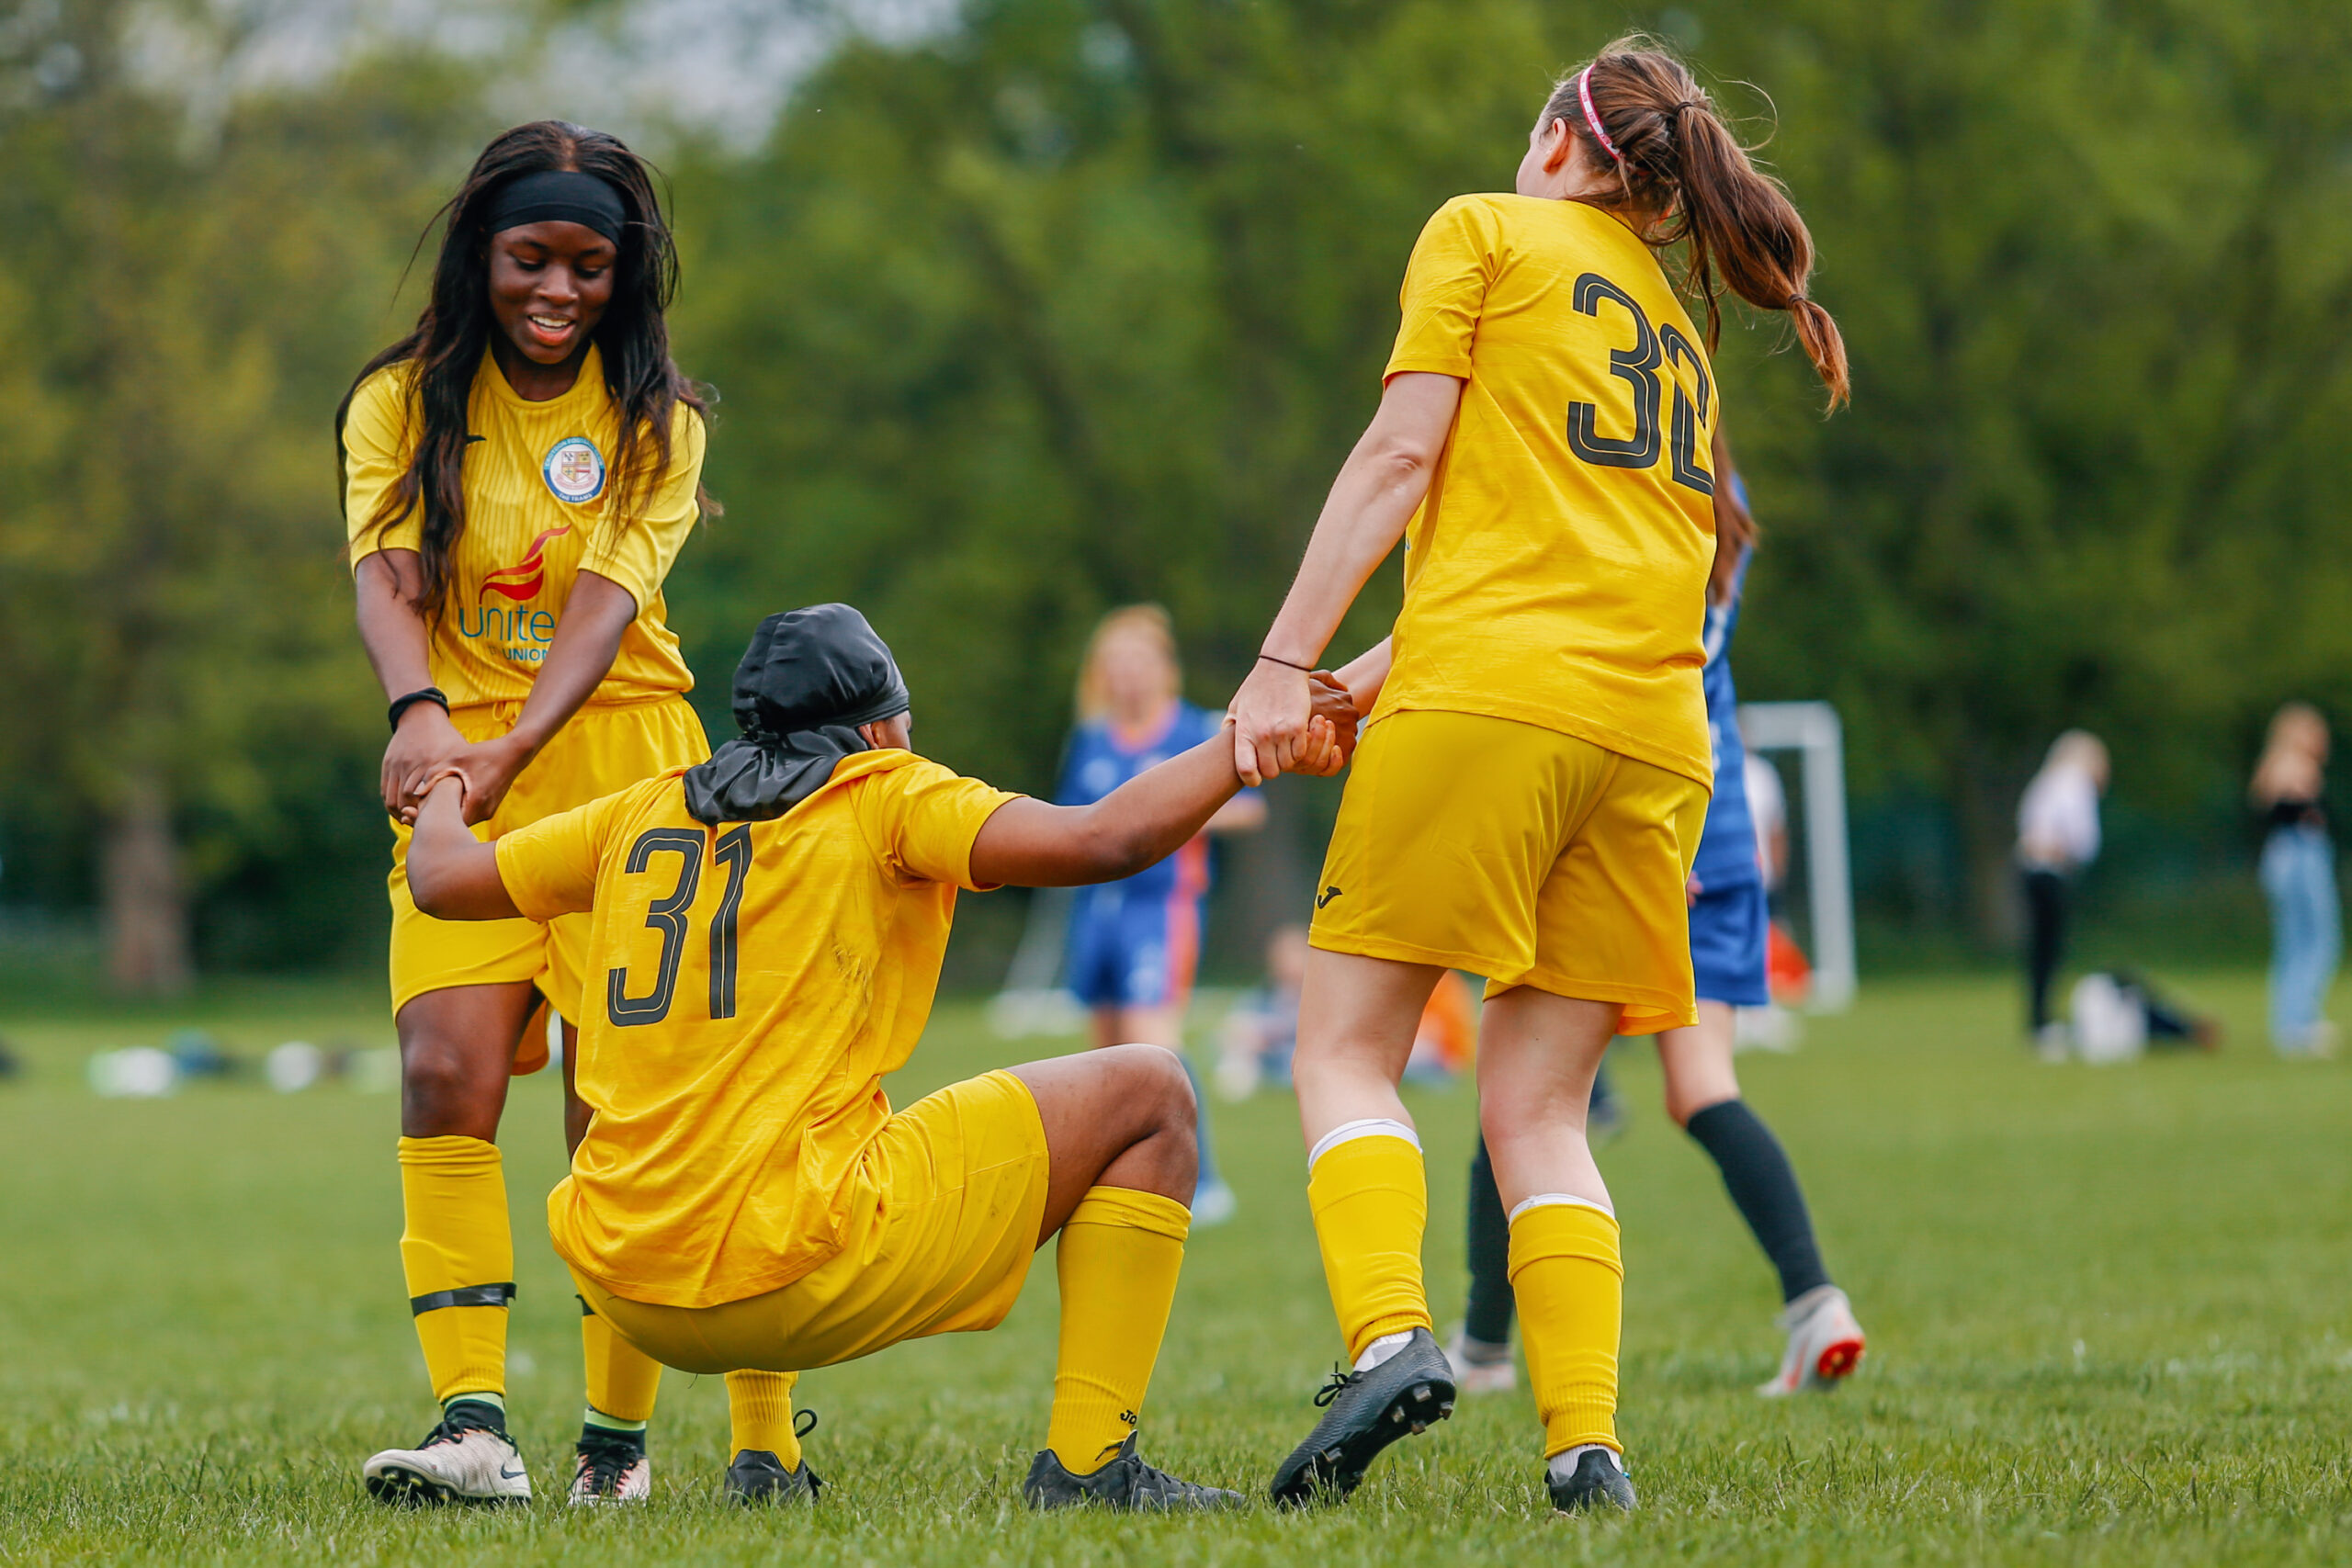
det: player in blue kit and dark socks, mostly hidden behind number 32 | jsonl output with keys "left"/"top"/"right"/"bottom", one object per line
{"left": 1446, "top": 430, "right": 1863, "bottom": 1396}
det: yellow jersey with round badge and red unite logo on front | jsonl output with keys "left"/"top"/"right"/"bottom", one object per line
{"left": 344, "top": 345, "right": 703, "bottom": 707}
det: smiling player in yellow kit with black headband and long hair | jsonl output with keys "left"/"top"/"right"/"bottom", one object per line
{"left": 336, "top": 120, "right": 793, "bottom": 1502}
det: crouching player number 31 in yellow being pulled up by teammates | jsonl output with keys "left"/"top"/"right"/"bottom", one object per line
{"left": 409, "top": 604, "right": 1355, "bottom": 1509}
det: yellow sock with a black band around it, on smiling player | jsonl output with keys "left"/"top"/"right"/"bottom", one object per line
{"left": 400, "top": 1138, "right": 515, "bottom": 1404}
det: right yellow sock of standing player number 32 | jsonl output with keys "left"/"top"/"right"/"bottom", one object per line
{"left": 1510, "top": 1203, "right": 1625, "bottom": 1458}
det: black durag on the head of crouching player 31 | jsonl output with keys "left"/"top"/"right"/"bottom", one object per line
{"left": 684, "top": 604, "right": 908, "bottom": 825}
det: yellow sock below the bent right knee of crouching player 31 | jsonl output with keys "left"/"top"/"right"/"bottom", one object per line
{"left": 1045, "top": 1187, "right": 1193, "bottom": 1476}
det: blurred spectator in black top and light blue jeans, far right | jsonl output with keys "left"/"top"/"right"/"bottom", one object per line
{"left": 2248, "top": 703, "right": 2343, "bottom": 1055}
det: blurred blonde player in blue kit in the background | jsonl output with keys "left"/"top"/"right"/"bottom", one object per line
{"left": 1054, "top": 604, "right": 1265, "bottom": 1224}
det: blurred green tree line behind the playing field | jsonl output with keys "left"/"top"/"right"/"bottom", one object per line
{"left": 0, "top": 0, "right": 2352, "bottom": 985}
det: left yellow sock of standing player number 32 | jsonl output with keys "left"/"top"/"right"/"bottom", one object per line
{"left": 1307, "top": 1134, "right": 1432, "bottom": 1361}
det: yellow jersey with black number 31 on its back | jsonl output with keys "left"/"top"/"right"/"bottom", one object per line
{"left": 499, "top": 750, "right": 1016, "bottom": 1307}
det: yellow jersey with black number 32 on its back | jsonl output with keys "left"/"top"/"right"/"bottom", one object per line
{"left": 1371, "top": 195, "right": 1717, "bottom": 785}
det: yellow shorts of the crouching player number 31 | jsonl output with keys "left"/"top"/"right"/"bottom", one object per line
{"left": 571, "top": 1072, "right": 1046, "bottom": 1373}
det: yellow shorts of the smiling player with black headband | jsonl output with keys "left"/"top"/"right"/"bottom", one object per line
{"left": 386, "top": 696, "right": 710, "bottom": 1072}
